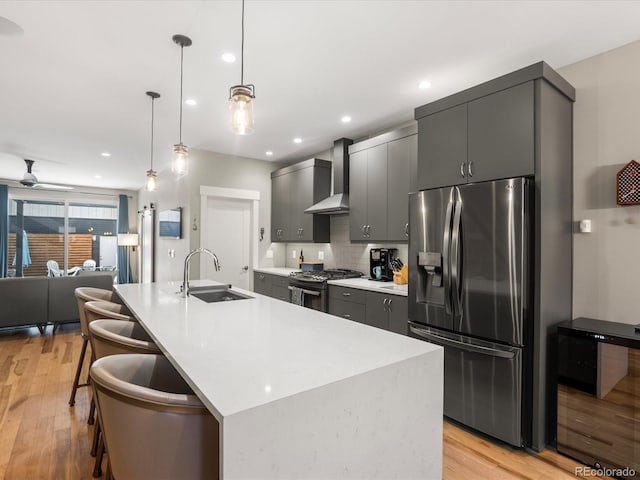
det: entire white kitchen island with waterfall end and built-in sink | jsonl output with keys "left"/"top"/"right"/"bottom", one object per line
{"left": 115, "top": 281, "right": 443, "bottom": 479}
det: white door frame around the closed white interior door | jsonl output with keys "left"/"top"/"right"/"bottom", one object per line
{"left": 200, "top": 185, "right": 260, "bottom": 289}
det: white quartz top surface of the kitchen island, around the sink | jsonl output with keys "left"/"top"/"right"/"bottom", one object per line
{"left": 115, "top": 280, "right": 440, "bottom": 420}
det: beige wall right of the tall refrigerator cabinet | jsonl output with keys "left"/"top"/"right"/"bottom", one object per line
{"left": 558, "top": 42, "right": 640, "bottom": 324}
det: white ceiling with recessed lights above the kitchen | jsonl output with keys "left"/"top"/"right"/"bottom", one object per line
{"left": 0, "top": 0, "right": 640, "bottom": 189}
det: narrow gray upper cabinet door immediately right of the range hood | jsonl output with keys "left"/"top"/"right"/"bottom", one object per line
{"left": 349, "top": 150, "right": 368, "bottom": 240}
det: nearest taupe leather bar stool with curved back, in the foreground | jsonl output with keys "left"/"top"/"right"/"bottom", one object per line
{"left": 91, "top": 354, "right": 219, "bottom": 480}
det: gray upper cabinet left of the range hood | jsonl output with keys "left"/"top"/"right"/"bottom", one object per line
{"left": 271, "top": 158, "right": 331, "bottom": 242}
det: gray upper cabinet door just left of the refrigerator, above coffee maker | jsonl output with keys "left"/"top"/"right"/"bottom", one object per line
{"left": 386, "top": 135, "right": 418, "bottom": 242}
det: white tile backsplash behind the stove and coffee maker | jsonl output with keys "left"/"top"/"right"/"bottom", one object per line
{"left": 261, "top": 215, "right": 408, "bottom": 275}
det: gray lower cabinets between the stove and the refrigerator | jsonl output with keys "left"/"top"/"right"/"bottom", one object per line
{"left": 329, "top": 285, "right": 408, "bottom": 335}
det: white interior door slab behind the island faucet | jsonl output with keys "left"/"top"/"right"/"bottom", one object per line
{"left": 200, "top": 197, "right": 251, "bottom": 290}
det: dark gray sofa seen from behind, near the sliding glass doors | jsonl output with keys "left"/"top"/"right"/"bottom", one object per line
{"left": 0, "top": 272, "right": 113, "bottom": 332}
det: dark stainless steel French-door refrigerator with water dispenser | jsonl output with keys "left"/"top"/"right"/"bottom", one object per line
{"left": 409, "top": 178, "right": 533, "bottom": 446}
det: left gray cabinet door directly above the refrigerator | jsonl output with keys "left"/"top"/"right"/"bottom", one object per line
{"left": 417, "top": 104, "right": 467, "bottom": 190}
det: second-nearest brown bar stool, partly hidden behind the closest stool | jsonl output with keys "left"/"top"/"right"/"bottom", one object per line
{"left": 89, "top": 319, "right": 162, "bottom": 477}
